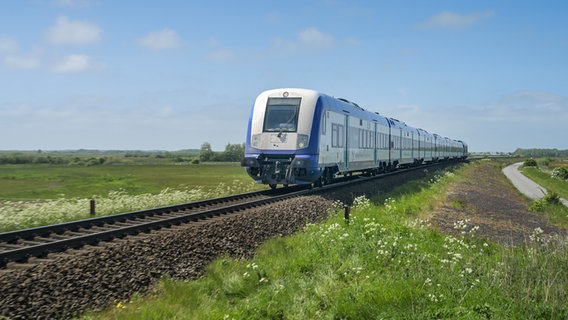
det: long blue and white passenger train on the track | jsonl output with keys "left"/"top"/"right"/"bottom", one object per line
{"left": 241, "top": 88, "right": 468, "bottom": 189}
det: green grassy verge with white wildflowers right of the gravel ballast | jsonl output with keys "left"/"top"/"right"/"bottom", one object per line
{"left": 84, "top": 163, "right": 568, "bottom": 319}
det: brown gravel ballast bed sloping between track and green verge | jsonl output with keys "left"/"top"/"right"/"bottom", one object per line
{"left": 0, "top": 164, "right": 452, "bottom": 319}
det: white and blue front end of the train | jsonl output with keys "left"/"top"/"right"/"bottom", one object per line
{"left": 241, "top": 89, "right": 321, "bottom": 188}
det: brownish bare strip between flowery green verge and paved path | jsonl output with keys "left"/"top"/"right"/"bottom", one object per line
{"left": 430, "top": 161, "right": 567, "bottom": 245}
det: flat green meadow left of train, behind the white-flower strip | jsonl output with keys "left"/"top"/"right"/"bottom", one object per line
{"left": 0, "top": 162, "right": 258, "bottom": 200}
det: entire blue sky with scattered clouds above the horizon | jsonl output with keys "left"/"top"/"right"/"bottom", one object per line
{"left": 0, "top": 0, "right": 568, "bottom": 152}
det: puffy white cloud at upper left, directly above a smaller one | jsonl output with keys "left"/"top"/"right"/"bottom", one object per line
{"left": 47, "top": 17, "right": 101, "bottom": 44}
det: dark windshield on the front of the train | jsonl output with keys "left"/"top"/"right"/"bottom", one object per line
{"left": 264, "top": 98, "right": 302, "bottom": 132}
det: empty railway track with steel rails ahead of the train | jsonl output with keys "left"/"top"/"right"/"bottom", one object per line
{"left": 0, "top": 187, "right": 309, "bottom": 268}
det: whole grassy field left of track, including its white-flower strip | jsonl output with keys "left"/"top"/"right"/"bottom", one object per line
{"left": 0, "top": 159, "right": 266, "bottom": 232}
